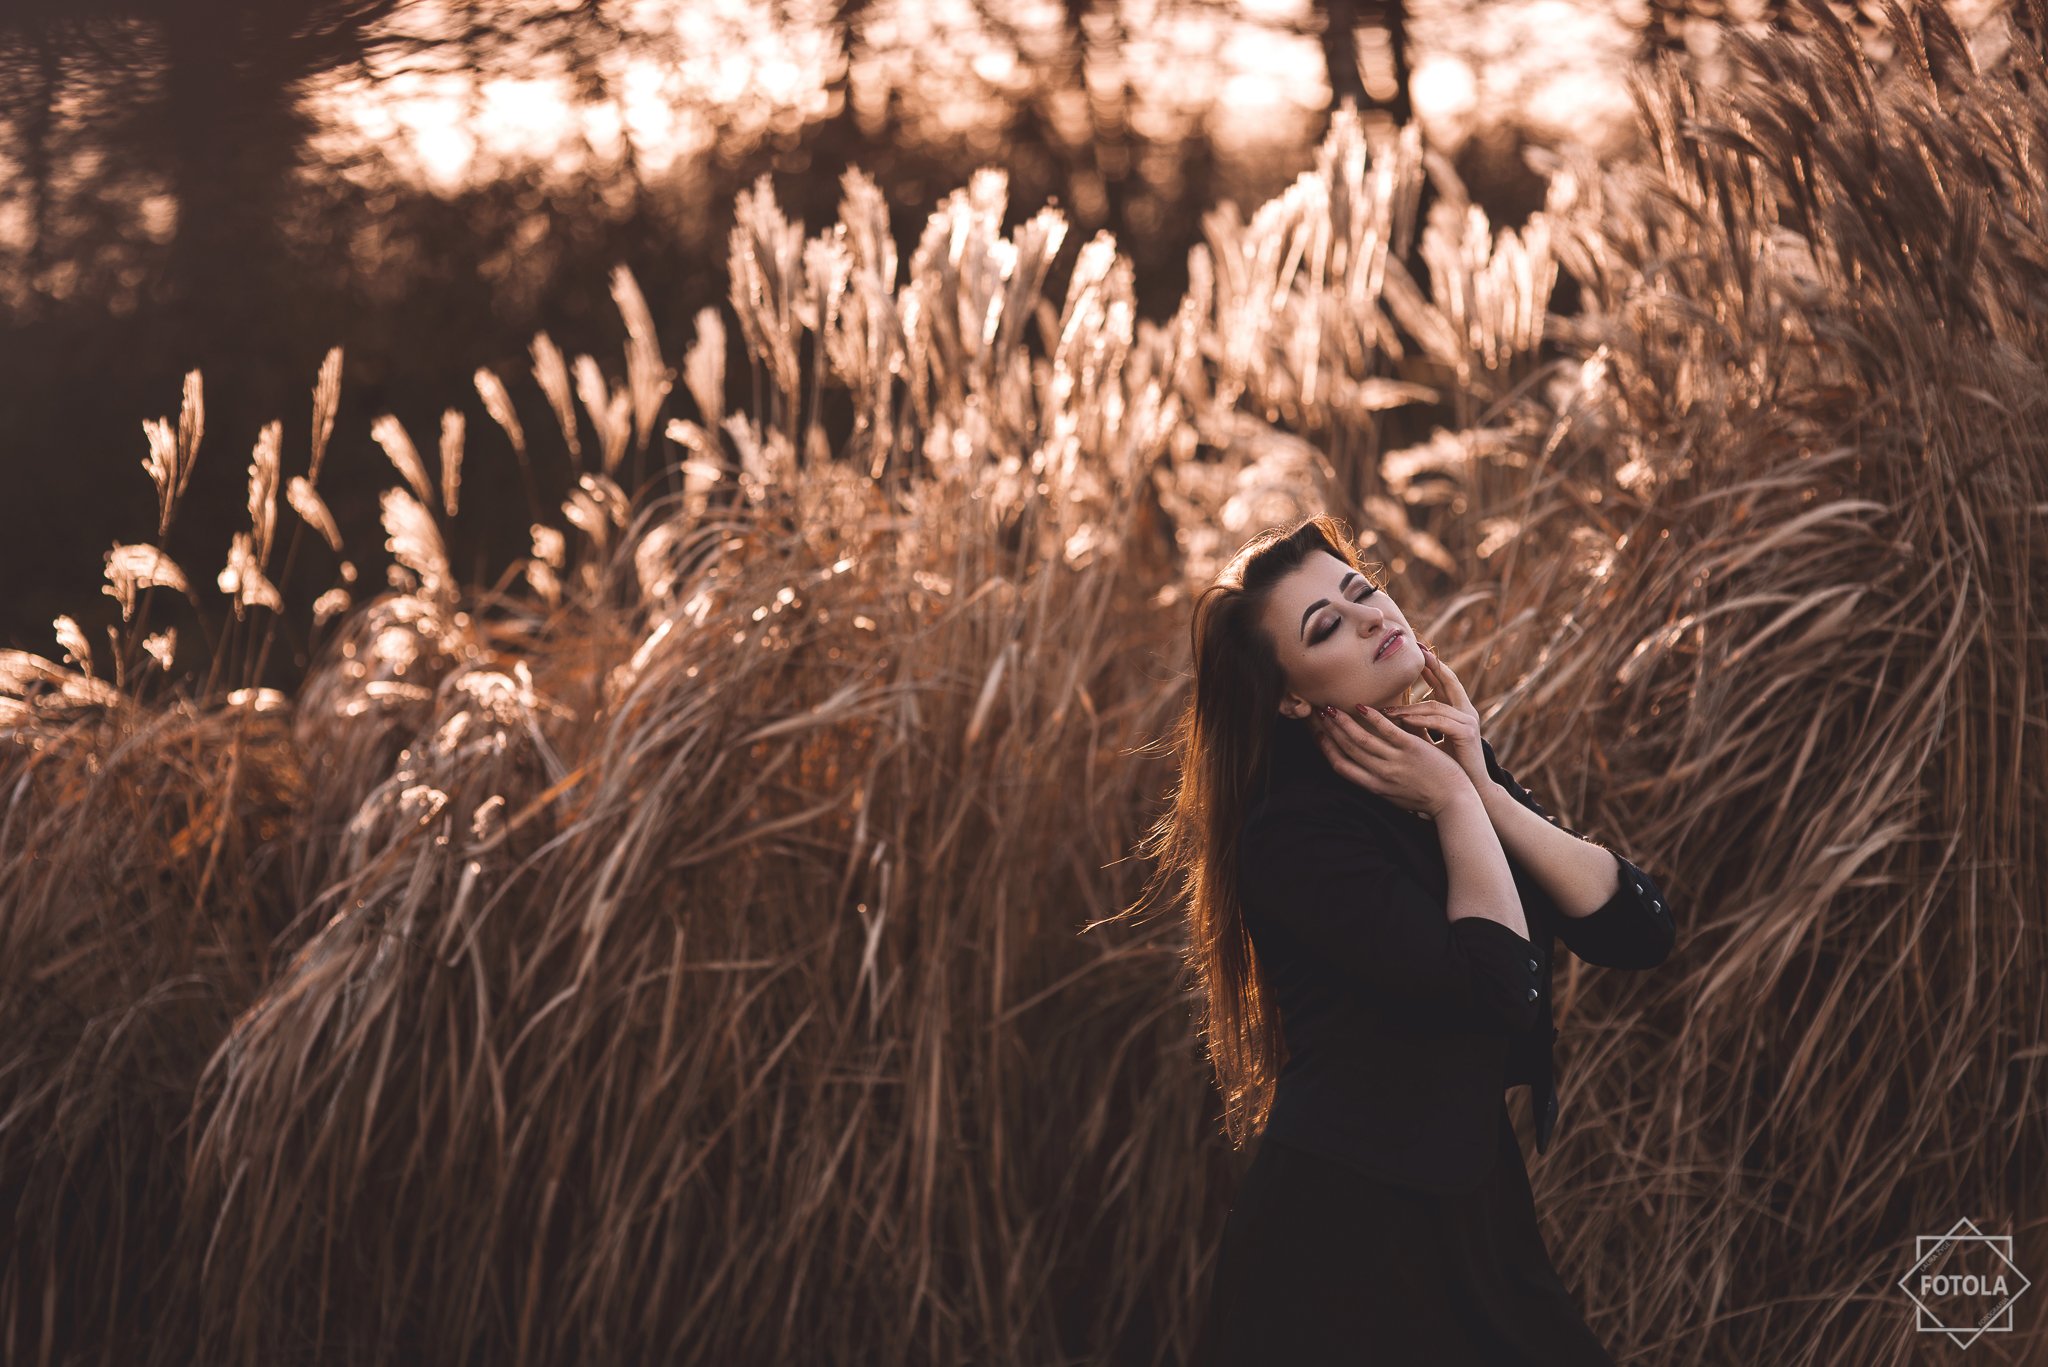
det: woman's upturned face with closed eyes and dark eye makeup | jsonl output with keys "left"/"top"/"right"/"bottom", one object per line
{"left": 1262, "top": 551, "right": 1423, "bottom": 717}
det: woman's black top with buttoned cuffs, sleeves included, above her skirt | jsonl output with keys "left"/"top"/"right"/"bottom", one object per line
{"left": 1237, "top": 717, "right": 1675, "bottom": 1191}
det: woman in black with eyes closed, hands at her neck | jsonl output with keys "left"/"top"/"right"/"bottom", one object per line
{"left": 1149, "top": 516, "right": 1673, "bottom": 1367}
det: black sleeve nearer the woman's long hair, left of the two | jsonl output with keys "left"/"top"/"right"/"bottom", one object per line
{"left": 1239, "top": 807, "right": 1540, "bottom": 1031}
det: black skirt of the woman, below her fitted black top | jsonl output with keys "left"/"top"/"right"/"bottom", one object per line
{"left": 1192, "top": 1099, "right": 1614, "bottom": 1367}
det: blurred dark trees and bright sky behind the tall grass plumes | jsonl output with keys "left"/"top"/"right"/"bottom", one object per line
{"left": 0, "top": 0, "right": 1995, "bottom": 664}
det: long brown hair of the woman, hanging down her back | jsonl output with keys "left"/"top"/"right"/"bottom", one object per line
{"left": 1124, "top": 514, "right": 1368, "bottom": 1148}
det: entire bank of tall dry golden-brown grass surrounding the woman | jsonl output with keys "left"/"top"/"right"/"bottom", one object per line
{"left": 0, "top": 12, "right": 2048, "bottom": 1363}
